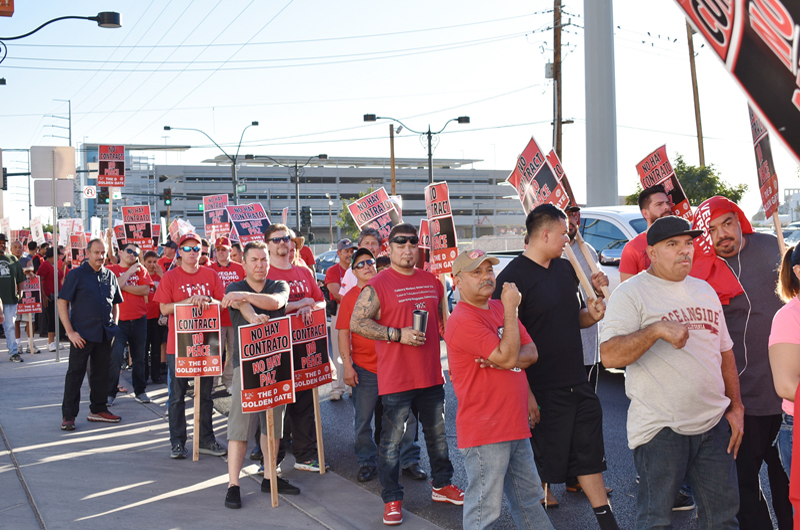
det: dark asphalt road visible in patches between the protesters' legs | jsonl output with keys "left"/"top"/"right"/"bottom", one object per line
{"left": 215, "top": 343, "right": 780, "bottom": 530}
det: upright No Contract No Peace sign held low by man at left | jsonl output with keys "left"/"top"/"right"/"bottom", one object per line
{"left": 175, "top": 304, "right": 222, "bottom": 377}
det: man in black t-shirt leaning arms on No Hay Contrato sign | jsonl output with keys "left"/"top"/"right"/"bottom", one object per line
{"left": 222, "top": 241, "right": 300, "bottom": 509}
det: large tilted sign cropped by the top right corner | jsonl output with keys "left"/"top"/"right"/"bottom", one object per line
{"left": 676, "top": 0, "right": 800, "bottom": 162}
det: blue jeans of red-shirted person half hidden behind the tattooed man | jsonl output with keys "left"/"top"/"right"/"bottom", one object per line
{"left": 353, "top": 364, "right": 420, "bottom": 469}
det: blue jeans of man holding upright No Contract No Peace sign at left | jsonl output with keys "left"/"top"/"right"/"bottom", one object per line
{"left": 167, "top": 355, "right": 216, "bottom": 447}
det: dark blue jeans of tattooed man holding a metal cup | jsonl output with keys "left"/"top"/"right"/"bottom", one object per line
{"left": 378, "top": 385, "right": 453, "bottom": 502}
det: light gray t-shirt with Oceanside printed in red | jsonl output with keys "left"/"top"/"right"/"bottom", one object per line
{"left": 600, "top": 271, "right": 733, "bottom": 449}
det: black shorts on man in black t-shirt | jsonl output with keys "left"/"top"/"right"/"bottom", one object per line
{"left": 531, "top": 383, "right": 606, "bottom": 484}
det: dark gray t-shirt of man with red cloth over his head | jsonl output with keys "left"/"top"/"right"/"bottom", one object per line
{"left": 722, "top": 233, "right": 783, "bottom": 416}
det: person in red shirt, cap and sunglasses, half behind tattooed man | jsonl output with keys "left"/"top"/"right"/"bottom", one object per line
{"left": 336, "top": 248, "right": 428, "bottom": 482}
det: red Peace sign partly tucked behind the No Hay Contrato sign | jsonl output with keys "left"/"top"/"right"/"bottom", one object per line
{"left": 290, "top": 309, "right": 333, "bottom": 392}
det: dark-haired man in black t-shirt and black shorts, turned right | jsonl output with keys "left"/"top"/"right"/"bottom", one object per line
{"left": 493, "top": 204, "right": 618, "bottom": 530}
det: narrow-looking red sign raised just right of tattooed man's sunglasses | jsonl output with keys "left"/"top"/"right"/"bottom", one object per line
{"left": 425, "top": 182, "right": 458, "bottom": 274}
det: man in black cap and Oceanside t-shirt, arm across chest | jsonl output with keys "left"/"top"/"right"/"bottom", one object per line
{"left": 600, "top": 216, "right": 744, "bottom": 530}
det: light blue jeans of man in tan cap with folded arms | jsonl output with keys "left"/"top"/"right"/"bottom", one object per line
{"left": 461, "top": 439, "right": 553, "bottom": 530}
